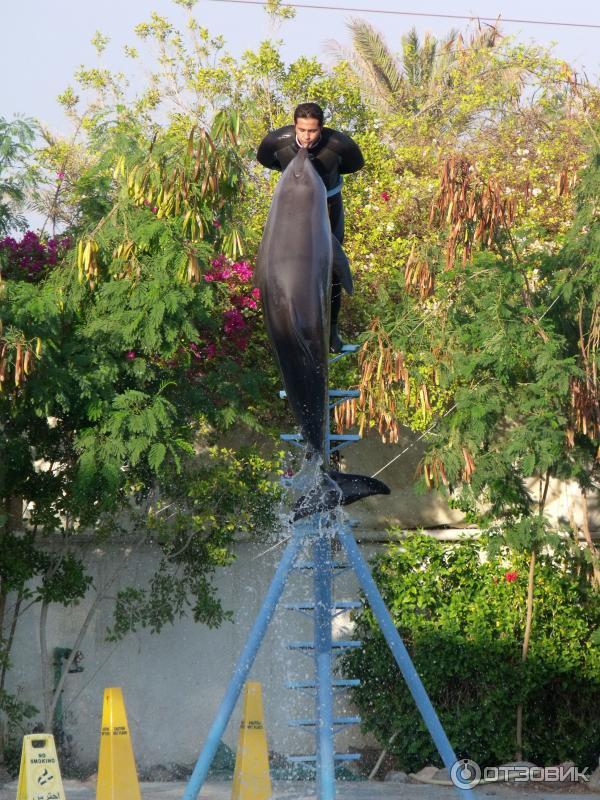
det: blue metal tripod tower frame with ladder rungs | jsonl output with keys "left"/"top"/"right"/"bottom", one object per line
{"left": 183, "top": 345, "right": 473, "bottom": 800}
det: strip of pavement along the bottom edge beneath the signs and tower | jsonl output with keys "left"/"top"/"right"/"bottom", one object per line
{"left": 0, "top": 780, "right": 600, "bottom": 800}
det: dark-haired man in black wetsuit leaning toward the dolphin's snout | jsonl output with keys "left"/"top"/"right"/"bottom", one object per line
{"left": 256, "top": 103, "right": 365, "bottom": 353}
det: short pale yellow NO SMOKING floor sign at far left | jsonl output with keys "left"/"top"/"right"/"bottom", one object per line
{"left": 17, "top": 733, "right": 65, "bottom": 800}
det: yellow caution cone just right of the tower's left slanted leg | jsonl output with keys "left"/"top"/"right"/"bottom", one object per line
{"left": 231, "top": 681, "right": 271, "bottom": 800}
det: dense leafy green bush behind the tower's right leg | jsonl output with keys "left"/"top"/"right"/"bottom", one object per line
{"left": 344, "top": 534, "right": 600, "bottom": 770}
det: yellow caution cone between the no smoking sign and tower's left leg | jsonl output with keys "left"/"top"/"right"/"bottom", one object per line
{"left": 96, "top": 688, "right": 141, "bottom": 800}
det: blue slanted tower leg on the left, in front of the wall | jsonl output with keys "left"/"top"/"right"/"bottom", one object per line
{"left": 183, "top": 526, "right": 304, "bottom": 800}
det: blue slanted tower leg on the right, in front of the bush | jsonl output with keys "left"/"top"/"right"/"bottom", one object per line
{"left": 338, "top": 525, "right": 473, "bottom": 800}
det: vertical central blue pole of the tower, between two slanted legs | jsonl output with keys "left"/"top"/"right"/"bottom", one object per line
{"left": 313, "top": 517, "right": 335, "bottom": 800}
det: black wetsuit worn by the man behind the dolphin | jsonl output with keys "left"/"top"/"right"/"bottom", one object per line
{"left": 256, "top": 125, "right": 365, "bottom": 334}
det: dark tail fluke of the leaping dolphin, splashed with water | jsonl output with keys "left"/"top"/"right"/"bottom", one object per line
{"left": 294, "top": 470, "right": 390, "bottom": 521}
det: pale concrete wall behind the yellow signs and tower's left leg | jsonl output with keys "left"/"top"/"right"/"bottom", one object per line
{"left": 8, "top": 543, "right": 380, "bottom": 767}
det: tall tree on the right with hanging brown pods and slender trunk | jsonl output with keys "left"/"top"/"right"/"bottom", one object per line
{"left": 341, "top": 32, "right": 600, "bottom": 758}
